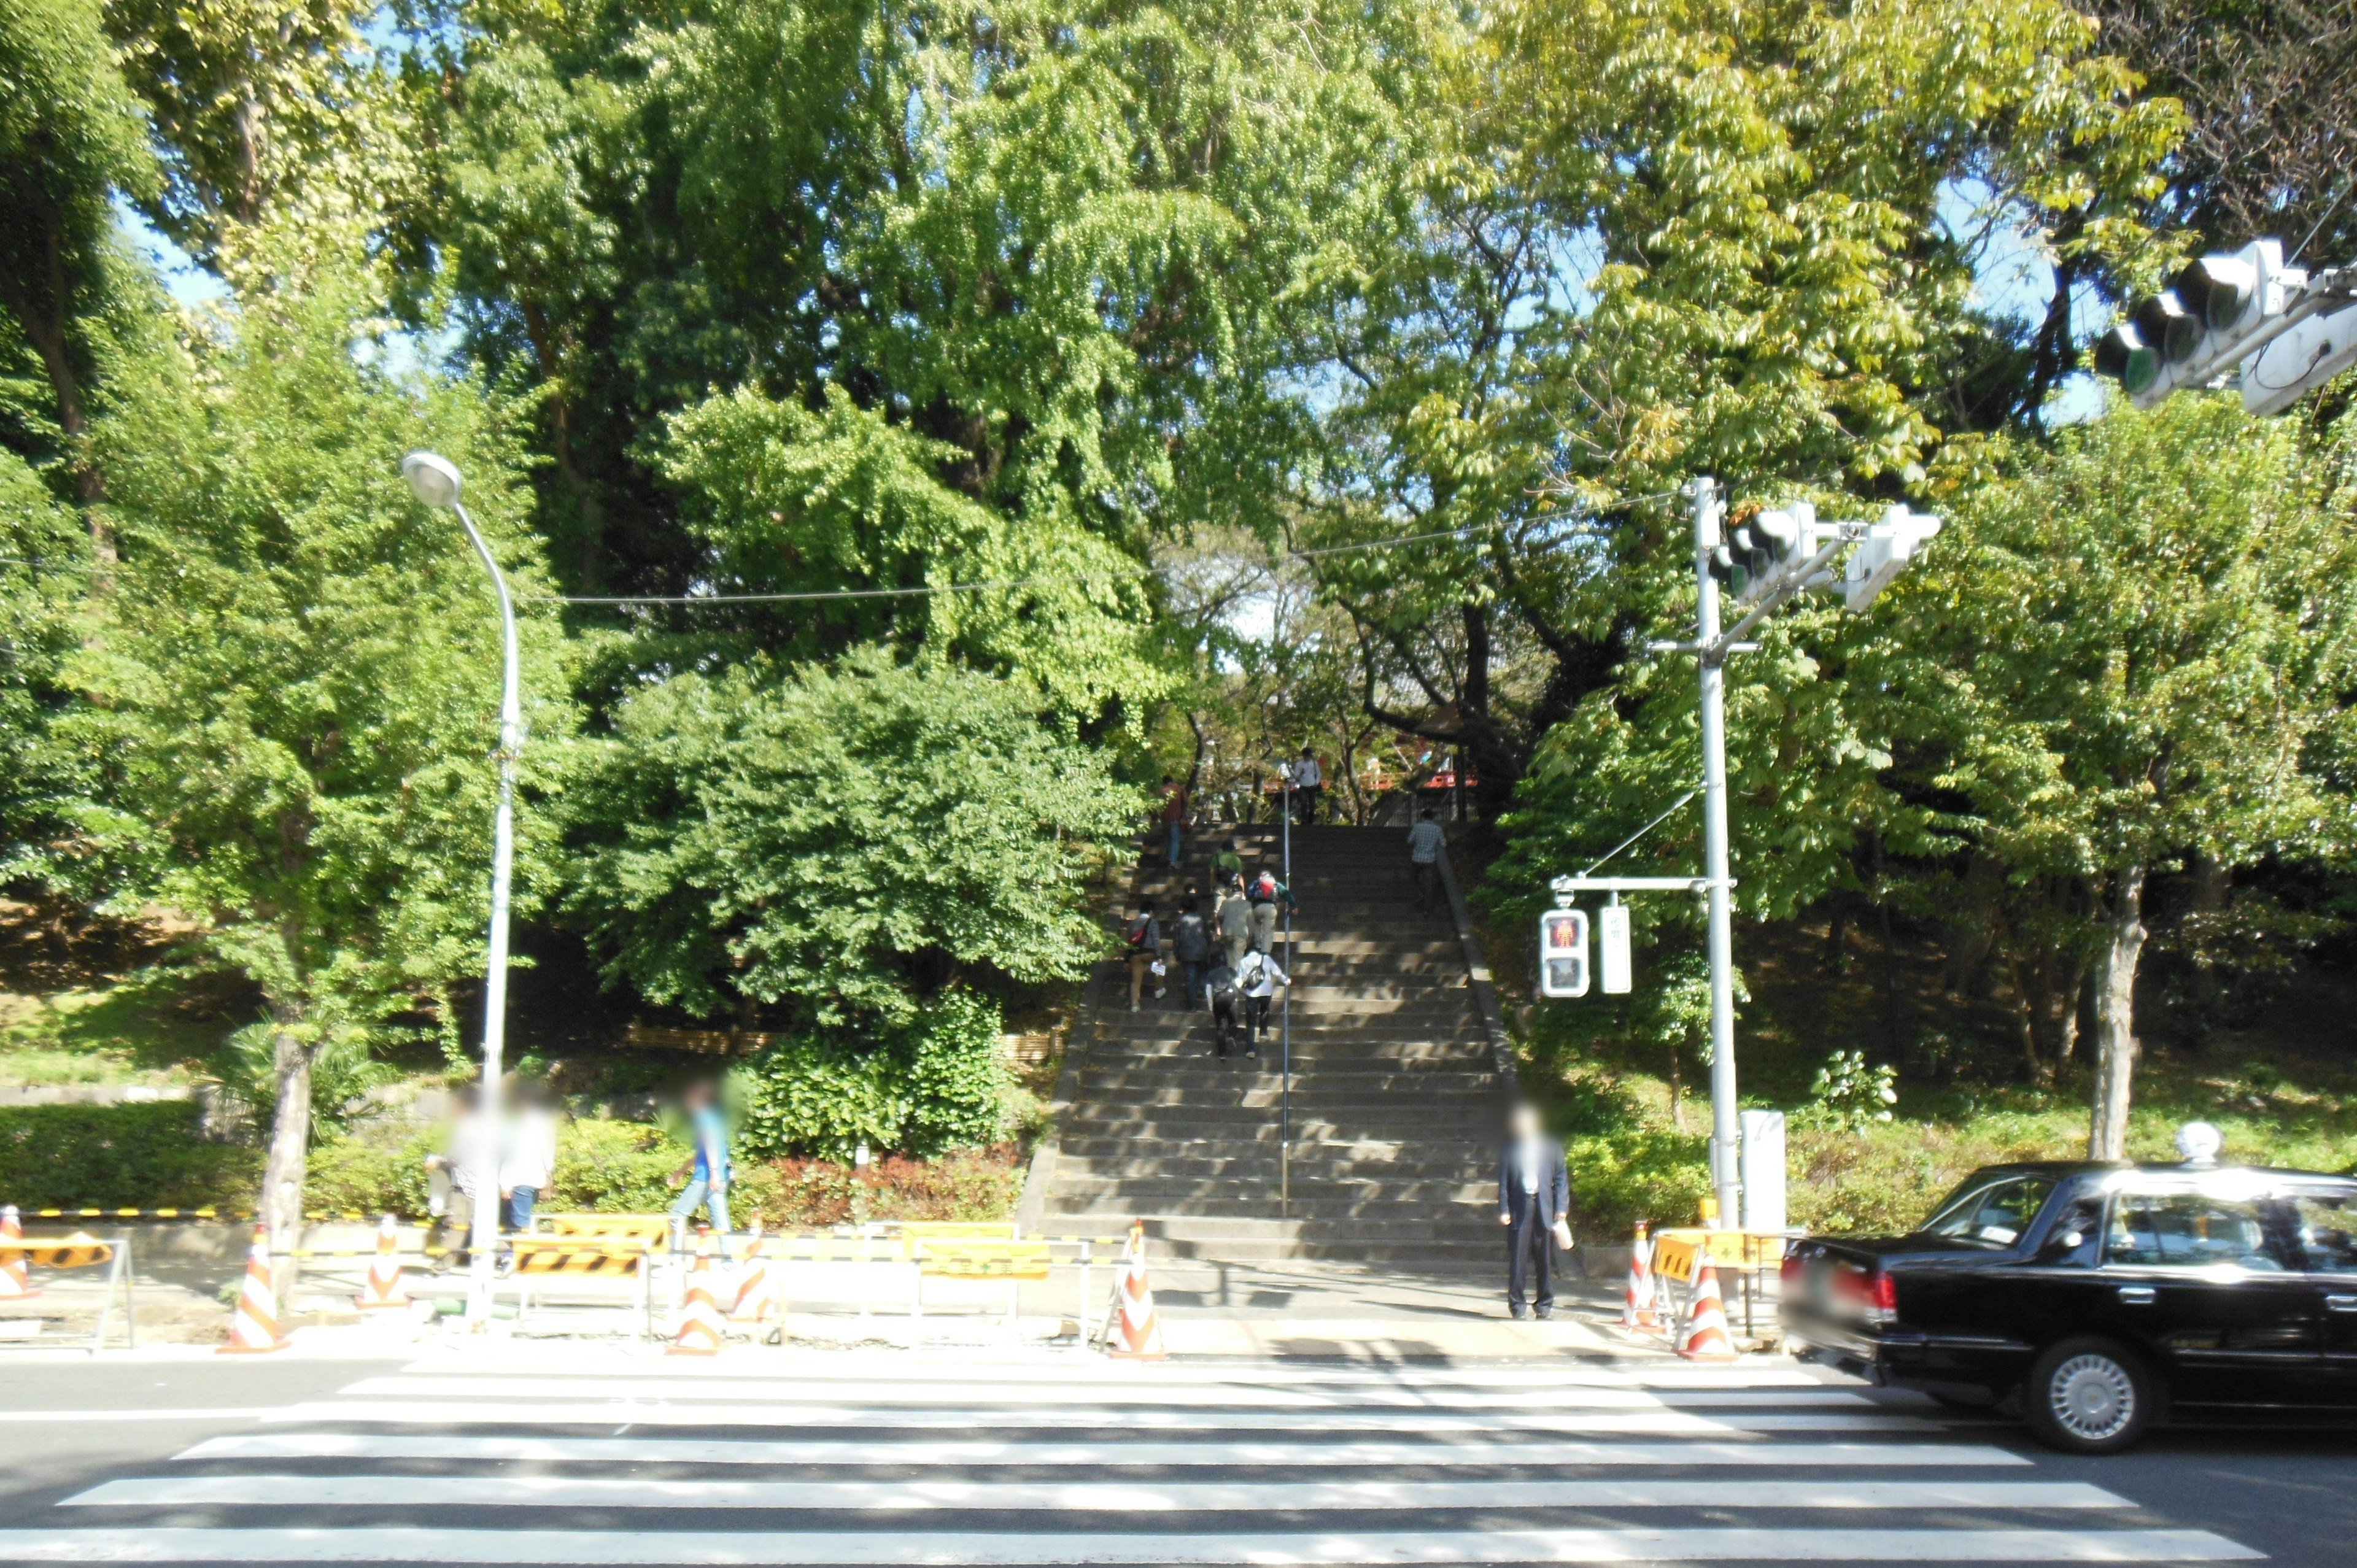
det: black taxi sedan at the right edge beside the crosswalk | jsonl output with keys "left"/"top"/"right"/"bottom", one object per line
{"left": 1779, "top": 1162, "right": 2357, "bottom": 1453}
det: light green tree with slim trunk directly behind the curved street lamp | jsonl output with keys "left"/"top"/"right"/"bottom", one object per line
{"left": 61, "top": 274, "right": 570, "bottom": 1245}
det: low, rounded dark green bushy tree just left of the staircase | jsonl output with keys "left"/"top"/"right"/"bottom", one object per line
{"left": 573, "top": 649, "right": 1143, "bottom": 1033}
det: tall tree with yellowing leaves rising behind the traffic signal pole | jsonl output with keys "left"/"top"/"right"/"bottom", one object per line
{"left": 1299, "top": 0, "right": 2175, "bottom": 825}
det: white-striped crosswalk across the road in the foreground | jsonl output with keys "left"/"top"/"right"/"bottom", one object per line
{"left": 0, "top": 1346, "right": 2261, "bottom": 1568}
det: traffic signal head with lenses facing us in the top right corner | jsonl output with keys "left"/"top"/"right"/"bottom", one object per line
{"left": 2096, "top": 241, "right": 2307, "bottom": 408}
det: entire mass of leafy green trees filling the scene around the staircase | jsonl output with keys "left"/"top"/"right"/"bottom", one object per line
{"left": 0, "top": 0, "right": 2350, "bottom": 1197}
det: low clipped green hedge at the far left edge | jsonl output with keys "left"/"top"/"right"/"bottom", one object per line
{"left": 0, "top": 1099, "right": 261, "bottom": 1210}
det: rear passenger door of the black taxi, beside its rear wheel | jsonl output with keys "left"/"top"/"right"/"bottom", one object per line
{"left": 2098, "top": 1184, "right": 2321, "bottom": 1405}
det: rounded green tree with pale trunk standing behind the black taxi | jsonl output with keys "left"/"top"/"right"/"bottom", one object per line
{"left": 1886, "top": 396, "right": 2357, "bottom": 1160}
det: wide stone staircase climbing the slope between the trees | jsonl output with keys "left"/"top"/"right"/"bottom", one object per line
{"left": 1025, "top": 828, "right": 1499, "bottom": 1276}
